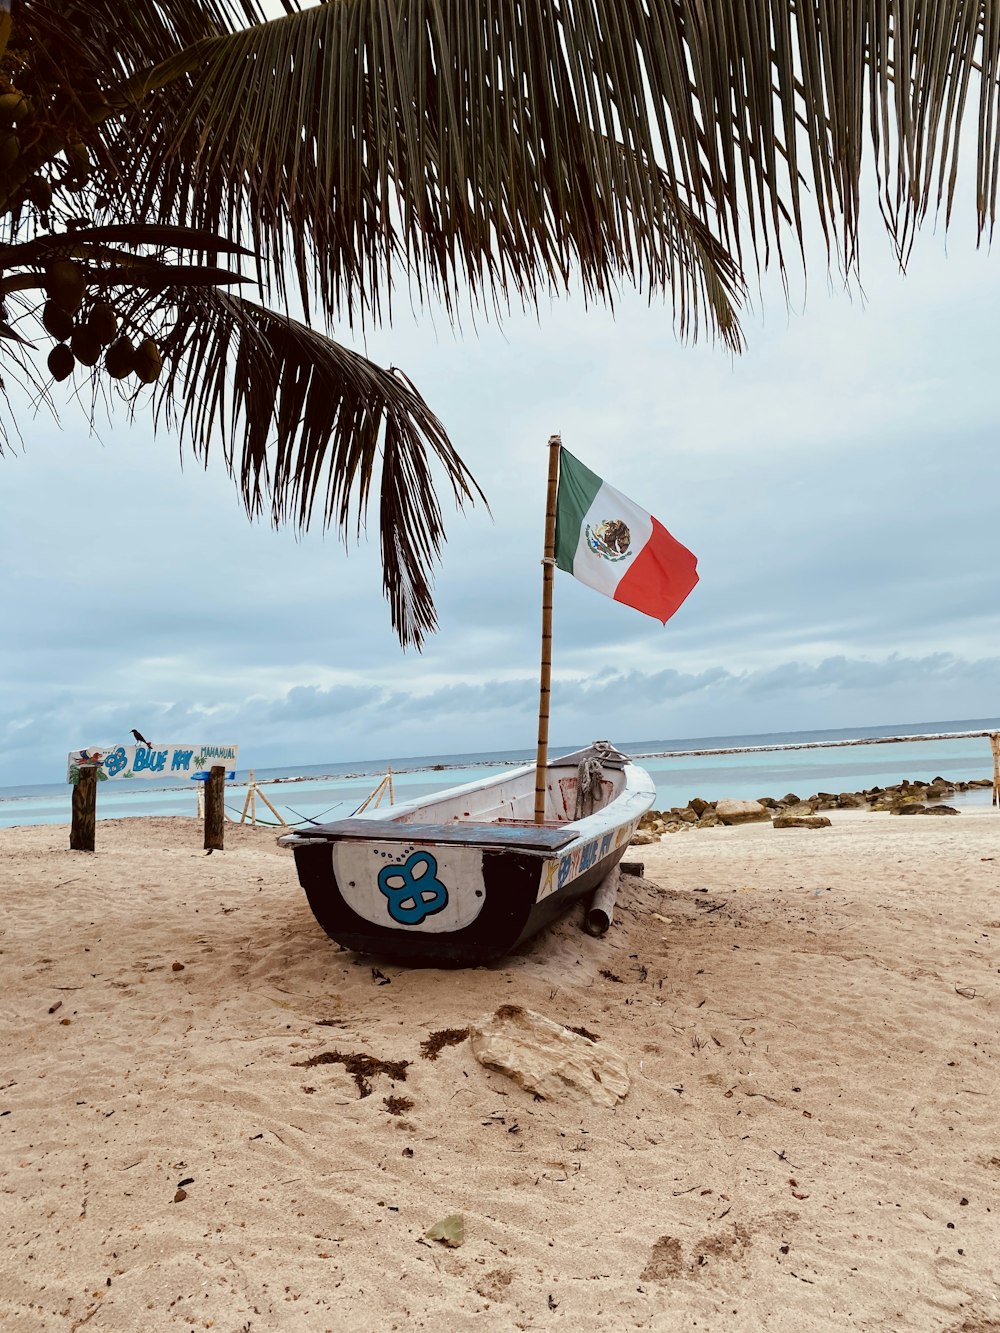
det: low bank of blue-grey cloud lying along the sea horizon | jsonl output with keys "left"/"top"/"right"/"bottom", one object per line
{"left": 0, "top": 653, "right": 1000, "bottom": 785}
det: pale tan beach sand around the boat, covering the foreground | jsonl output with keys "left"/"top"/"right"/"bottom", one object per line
{"left": 0, "top": 810, "right": 1000, "bottom": 1333}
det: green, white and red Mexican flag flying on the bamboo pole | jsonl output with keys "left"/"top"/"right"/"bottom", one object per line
{"left": 556, "top": 448, "right": 697, "bottom": 624}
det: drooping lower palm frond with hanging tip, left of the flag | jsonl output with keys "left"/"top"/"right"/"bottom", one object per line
{"left": 157, "top": 289, "right": 481, "bottom": 647}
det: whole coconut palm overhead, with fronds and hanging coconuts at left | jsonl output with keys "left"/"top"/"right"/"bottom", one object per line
{"left": 0, "top": 0, "right": 1000, "bottom": 644}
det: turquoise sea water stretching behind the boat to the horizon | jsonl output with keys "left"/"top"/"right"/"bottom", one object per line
{"left": 0, "top": 717, "right": 1000, "bottom": 828}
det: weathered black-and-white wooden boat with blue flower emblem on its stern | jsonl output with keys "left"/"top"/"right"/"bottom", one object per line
{"left": 279, "top": 741, "right": 656, "bottom": 966}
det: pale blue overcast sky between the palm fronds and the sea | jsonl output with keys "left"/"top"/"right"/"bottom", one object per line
{"left": 0, "top": 203, "right": 1000, "bottom": 786}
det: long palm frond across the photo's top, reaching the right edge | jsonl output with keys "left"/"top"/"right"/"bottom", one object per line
{"left": 96, "top": 0, "right": 1000, "bottom": 316}
